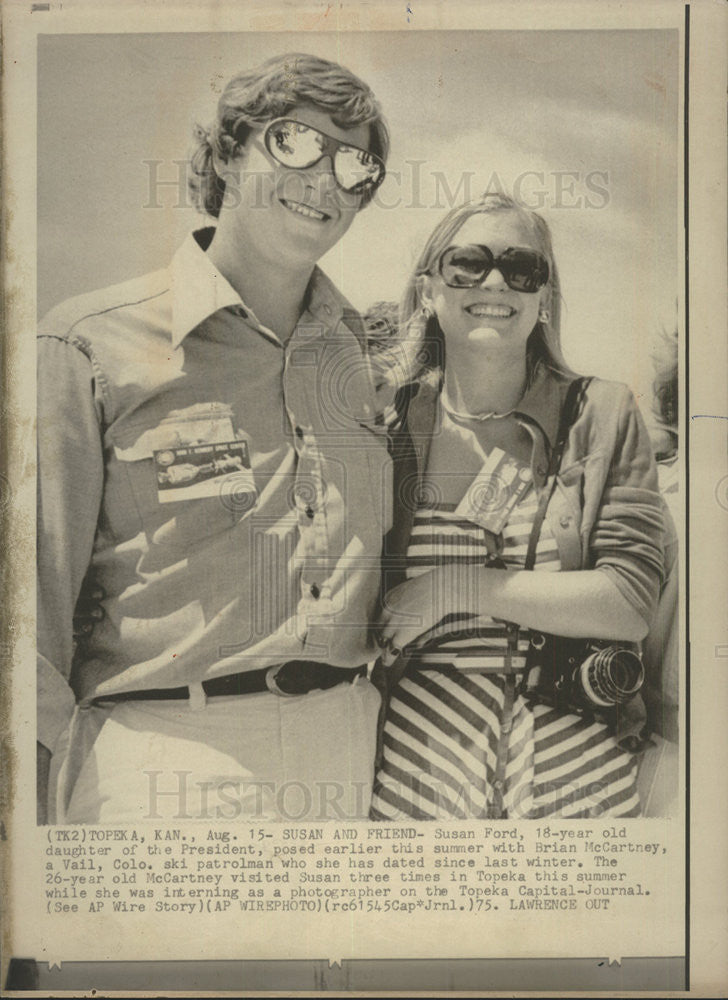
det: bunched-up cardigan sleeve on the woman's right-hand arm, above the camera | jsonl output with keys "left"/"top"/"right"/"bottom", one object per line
{"left": 590, "top": 387, "right": 664, "bottom": 624}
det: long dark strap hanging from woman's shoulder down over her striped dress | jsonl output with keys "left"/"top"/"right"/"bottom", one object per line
{"left": 488, "top": 376, "right": 591, "bottom": 819}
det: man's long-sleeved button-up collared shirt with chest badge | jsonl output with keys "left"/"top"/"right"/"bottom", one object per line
{"left": 38, "top": 230, "right": 391, "bottom": 749}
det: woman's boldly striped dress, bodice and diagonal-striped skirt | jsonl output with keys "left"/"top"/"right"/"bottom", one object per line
{"left": 371, "top": 489, "right": 640, "bottom": 820}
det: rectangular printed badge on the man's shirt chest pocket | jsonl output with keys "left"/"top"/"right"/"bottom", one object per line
{"left": 154, "top": 440, "right": 257, "bottom": 504}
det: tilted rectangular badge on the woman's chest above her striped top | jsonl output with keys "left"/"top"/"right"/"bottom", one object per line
{"left": 455, "top": 448, "right": 533, "bottom": 535}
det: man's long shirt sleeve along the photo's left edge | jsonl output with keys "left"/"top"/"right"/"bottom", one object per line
{"left": 37, "top": 336, "right": 104, "bottom": 751}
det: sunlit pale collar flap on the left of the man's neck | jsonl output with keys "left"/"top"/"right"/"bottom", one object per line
{"left": 170, "top": 226, "right": 244, "bottom": 348}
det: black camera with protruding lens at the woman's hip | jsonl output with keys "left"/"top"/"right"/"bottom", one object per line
{"left": 523, "top": 632, "right": 645, "bottom": 723}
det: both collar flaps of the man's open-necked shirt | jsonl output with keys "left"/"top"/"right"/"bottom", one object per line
{"left": 170, "top": 226, "right": 348, "bottom": 348}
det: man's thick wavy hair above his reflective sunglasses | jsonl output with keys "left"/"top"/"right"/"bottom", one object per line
{"left": 188, "top": 52, "right": 389, "bottom": 218}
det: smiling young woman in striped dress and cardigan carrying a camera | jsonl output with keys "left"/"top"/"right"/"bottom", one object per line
{"left": 372, "top": 195, "right": 663, "bottom": 819}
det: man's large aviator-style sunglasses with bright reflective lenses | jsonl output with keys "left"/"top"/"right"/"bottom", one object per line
{"left": 265, "top": 118, "right": 385, "bottom": 194}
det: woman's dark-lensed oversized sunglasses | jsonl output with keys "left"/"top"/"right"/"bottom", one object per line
{"left": 438, "top": 243, "right": 549, "bottom": 292}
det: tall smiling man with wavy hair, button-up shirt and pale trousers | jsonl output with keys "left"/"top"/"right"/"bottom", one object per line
{"left": 38, "top": 55, "right": 391, "bottom": 822}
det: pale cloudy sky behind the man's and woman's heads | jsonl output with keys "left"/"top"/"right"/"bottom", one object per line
{"left": 38, "top": 30, "right": 680, "bottom": 408}
